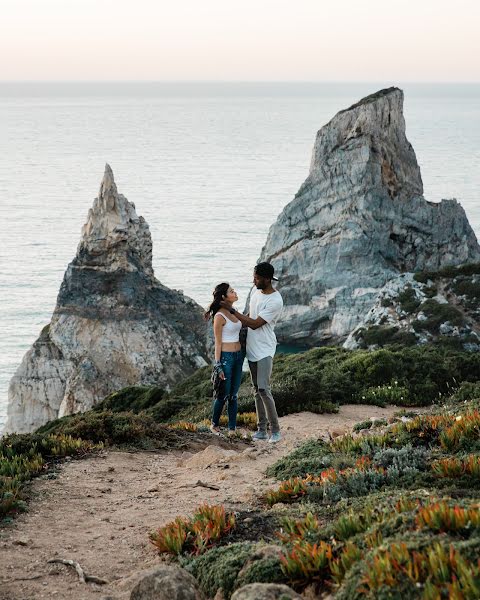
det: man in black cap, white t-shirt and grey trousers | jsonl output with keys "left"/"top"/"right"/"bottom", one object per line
{"left": 224, "top": 262, "right": 283, "bottom": 443}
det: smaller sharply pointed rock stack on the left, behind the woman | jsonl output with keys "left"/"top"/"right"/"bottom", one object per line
{"left": 6, "top": 165, "right": 208, "bottom": 432}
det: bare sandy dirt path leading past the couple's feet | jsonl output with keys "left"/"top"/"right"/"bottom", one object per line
{"left": 0, "top": 405, "right": 416, "bottom": 600}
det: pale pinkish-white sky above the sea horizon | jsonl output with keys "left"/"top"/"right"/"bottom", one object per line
{"left": 0, "top": 0, "right": 480, "bottom": 82}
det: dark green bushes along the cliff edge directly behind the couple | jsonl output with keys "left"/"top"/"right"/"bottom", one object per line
{"left": 64, "top": 345, "right": 480, "bottom": 427}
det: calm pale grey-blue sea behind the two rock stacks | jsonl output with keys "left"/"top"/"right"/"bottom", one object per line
{"left": 0, "top": 83, "right": 480, "bottom": 428}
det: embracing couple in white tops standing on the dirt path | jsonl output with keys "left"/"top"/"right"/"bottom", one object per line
{"left": 205, "top": 262, "right": 283, "bottom": 443}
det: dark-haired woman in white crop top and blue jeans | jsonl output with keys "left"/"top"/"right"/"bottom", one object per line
{"left": 205, "top": 283, "right": 245, "bottom": 435}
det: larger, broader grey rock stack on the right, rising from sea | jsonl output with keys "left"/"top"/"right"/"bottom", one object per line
{"left": 260, "top": 88, "right": 480, "bottom": 346}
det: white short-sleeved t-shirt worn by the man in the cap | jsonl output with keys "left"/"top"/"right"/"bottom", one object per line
{"left": 247, "top": 290, "right": 283, "bottom": 362}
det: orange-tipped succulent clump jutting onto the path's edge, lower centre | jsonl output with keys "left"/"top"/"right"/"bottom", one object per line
{"left": 150, "top": 504, "right": 235, "bottom": 555}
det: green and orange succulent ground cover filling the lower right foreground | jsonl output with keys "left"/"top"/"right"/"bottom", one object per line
{"left": 179, "top": 396, "right": 480, "bottom": 600}
